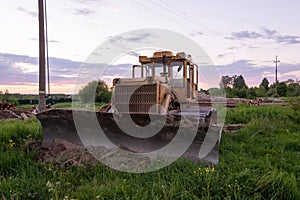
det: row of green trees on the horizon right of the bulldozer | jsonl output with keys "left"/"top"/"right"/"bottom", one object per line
{"left": 207, "top": 75, "right": 300, "bottom": 99}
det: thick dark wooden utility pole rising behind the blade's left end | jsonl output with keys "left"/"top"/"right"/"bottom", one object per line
{"left": 38, "top": 0, "right": 46, "bottom": 112}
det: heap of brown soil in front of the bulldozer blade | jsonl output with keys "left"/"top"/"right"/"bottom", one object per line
{"left": 29, "top": 139, "right": 149, "bottom": 168}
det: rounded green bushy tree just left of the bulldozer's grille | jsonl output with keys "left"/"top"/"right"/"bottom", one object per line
{"left": 78, "top": 80, "right": 111, "bottom": 103}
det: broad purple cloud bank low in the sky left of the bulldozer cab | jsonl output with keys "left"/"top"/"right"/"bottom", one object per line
{"left": 0, "top": 53, "right": 137, "bottom": 91}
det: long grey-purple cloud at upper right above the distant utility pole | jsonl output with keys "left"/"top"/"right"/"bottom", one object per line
{"left": 226, "top": 28, "right": 300, "bottom": 44}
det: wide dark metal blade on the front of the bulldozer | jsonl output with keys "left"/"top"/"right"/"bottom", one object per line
{"left": 37, "top": 109, "right": 222, "bottom": 164}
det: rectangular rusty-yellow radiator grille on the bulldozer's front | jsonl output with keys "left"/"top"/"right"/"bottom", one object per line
{"left": 113, "top": 84, "right": 159, "bottom": 113}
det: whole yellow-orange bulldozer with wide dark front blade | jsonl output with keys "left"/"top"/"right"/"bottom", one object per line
{"left": 37, "top": 51, "right": 221, "bottom": 167}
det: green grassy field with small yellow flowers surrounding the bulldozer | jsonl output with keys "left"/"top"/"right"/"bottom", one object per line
{"left": 0, "top": 104, "right": 300, "bottom": 200}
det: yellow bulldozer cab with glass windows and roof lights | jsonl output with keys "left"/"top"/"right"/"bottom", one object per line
{"left": 137, "top": 51, "right": 198, "bottom": 101}
